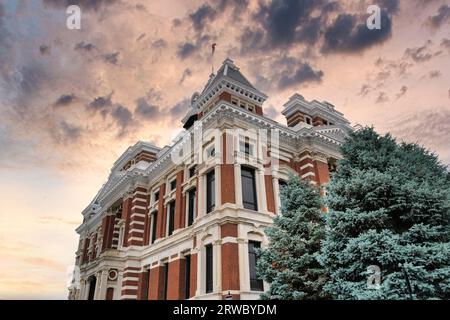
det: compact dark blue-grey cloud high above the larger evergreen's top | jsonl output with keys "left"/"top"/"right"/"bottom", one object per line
{"left": 322, "top": 10, "right": 392, "bottom": 53}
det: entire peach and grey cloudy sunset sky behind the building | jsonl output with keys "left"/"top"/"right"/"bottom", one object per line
{"left": 0, "top": 0, "right": 450, "bottom": 299}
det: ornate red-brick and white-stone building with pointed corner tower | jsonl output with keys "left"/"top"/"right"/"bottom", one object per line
{"left": 69, "top": 59, "right": 351, "bottom": 300}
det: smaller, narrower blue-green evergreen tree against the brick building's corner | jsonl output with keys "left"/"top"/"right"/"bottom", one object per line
{"left": 257, "top": 175, "right": 326, "bottom": 300}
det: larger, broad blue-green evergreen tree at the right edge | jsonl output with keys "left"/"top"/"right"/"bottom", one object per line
{"left": 319, "top": 128, "right": 450, "bottom": 299}
